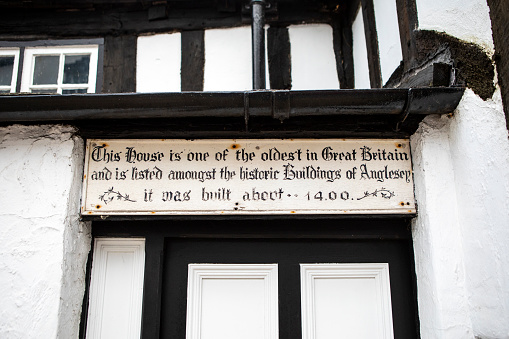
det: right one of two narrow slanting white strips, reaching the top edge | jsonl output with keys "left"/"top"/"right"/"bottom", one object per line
{"left": 373, "top": 0, "right": 403, "bottom": 84}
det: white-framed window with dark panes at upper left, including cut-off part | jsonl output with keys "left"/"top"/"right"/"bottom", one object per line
{"left": 0, "top": 39, "right": 103, "bottom": 94}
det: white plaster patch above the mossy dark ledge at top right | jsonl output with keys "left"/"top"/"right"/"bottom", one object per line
{"left": 416, "top": 0, "right": 493, "bottom": 51}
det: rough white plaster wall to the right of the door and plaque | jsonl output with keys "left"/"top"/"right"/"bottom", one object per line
{"left": 411, "top": 89, "right": 509, "bottom": 339}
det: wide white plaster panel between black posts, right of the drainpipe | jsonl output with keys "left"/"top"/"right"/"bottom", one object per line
{"left": 288, "top": 24, "right": 339, "bottom": 90}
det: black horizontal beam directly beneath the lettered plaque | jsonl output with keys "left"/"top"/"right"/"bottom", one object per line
{"left": 92, "top": 219, "right": 411, "bottom": 240}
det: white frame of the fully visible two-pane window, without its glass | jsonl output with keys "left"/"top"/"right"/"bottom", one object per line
{"left": 21, "top": 45, "right": 99, "bottom": 94}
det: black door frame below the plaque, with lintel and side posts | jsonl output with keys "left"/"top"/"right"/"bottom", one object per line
{"left": 80, "top": 215, "right": 420, "bottom": 339}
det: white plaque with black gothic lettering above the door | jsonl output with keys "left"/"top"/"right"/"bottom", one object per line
{"left": 82, "top": 139, "right": 415, "bottom": 215}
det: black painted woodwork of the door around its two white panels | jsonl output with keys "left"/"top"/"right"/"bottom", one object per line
{"left": 161, "top": 238, "right": 417, "bottom": 339}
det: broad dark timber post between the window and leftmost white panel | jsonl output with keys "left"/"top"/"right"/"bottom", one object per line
{"left": 103, "top": 35, "right": 137, "bottom": 93}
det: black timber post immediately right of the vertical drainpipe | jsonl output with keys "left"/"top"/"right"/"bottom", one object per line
{"left": 267, "top": 26, "right": 292, "bottom": 90}
